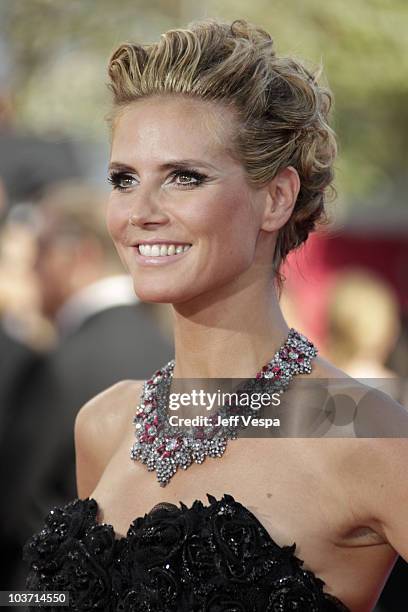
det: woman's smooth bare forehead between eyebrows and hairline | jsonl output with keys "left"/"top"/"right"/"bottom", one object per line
{"left": 111, "top": 95, "right": 237, "bottom": 162}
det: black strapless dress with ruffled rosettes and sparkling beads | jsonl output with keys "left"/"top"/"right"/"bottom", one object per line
{"left": 23, "top": 494, "right": 349, "bottom": 612}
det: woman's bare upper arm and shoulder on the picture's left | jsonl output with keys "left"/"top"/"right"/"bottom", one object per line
{"left": 74, "top": 380, "right": 140, "bottom": 499}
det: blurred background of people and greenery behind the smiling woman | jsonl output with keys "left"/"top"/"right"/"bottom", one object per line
{"left": 0, "top": 0, "right": 408, "bottom": 612}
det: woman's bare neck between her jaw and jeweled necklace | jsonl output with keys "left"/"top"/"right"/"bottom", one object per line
{"left": 173, "top": 281, "right": 289, "bottom": 378}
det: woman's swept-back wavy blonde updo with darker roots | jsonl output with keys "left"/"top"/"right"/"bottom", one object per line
{"left": 108, "top": 19, "right": 336, "bottom": 284}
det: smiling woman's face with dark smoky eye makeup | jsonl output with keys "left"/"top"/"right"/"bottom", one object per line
{"left": 107, "top": 96, "right": 271, "bottom": 304}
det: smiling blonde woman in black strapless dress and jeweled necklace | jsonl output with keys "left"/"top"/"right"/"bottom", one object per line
{"left": 25, "top": 20, "right": 408, "bottom": 612}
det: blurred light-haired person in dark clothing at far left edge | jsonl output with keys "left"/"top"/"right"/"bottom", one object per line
{"left": 0, "top": 209, "right": 53, "bottom": 589}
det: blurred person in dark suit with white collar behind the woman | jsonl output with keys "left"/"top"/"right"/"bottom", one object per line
{"left": 0, "top": 182, "right": 172, "bottom": 588}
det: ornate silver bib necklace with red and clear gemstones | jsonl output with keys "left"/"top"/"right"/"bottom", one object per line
{"left": 130, "top": 328, "right": 317, "bottom": 487}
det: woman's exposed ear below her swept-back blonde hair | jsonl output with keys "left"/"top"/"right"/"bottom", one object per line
{"left": 261, "top": 166, "right": 300, "bottom": 232}
